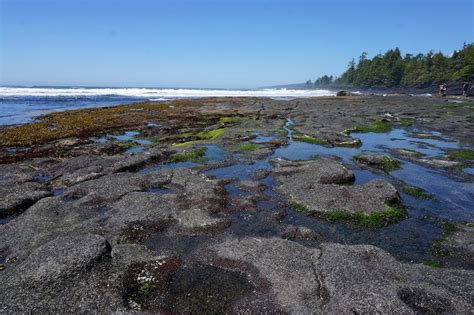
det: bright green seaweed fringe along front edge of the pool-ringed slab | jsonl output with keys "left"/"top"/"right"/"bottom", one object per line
{"left": 323, "top": 205, "right": 407, "bottom": 229}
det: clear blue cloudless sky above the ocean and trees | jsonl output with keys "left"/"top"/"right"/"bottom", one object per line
{"left": 0, "top": 0, "right": 474, "bottom": 88}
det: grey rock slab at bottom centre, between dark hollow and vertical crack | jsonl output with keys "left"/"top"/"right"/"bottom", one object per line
{"left": 211, "top": 238, "right": 322, "bottom": 314}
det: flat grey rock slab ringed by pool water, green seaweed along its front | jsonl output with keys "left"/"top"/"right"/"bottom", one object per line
{"left": 273, "top": 157, "right": 399, "bottom": 214}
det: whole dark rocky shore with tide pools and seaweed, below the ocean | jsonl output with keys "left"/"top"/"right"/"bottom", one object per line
{"left": 0, "top": 95, "right": 474, "bottom": 314}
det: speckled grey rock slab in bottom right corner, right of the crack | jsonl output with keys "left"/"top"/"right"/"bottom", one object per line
{"left": 315, "top": 243, "right": 474, "bottom": 314}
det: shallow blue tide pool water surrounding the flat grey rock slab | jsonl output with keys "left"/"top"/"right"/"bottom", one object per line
{"left": 146, "top": 120, "right": 474, "bottom": 262}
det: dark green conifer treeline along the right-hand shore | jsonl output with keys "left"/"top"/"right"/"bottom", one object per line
{"left": 312, "top": 43, "right": 474, "bottom": 88}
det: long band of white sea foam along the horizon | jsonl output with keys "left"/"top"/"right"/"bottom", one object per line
{"left": 0, "top": 87, "right": 335, "bottom": 100}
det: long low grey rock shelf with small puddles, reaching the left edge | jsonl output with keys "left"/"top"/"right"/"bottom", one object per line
{"left": 0, "top": 168, "right": 228, "bottom": 262}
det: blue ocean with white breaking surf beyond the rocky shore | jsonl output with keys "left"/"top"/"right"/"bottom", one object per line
{"left": 0, "top": 87, "right": 335, "bottom": 125}
